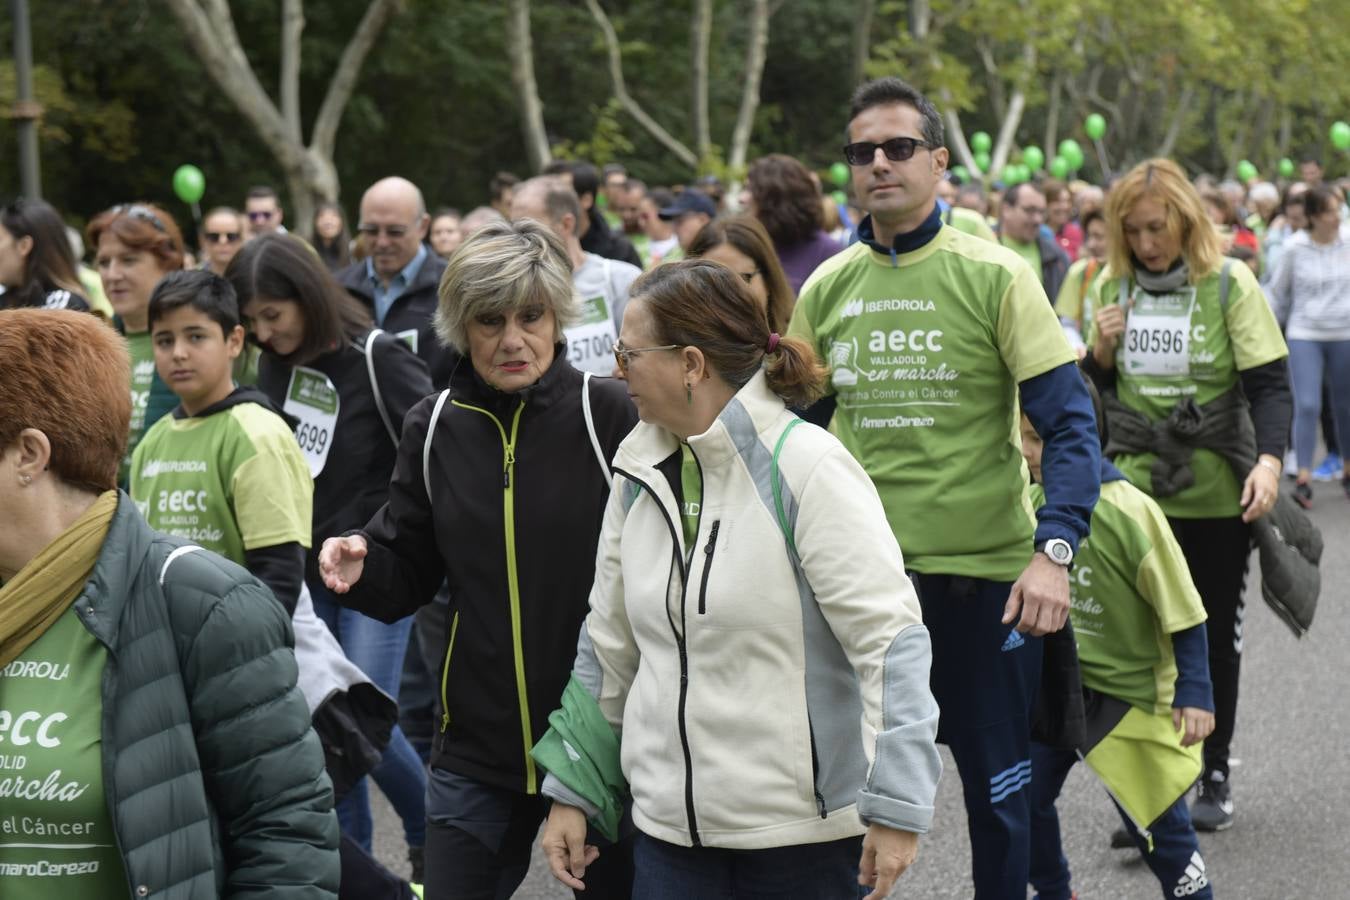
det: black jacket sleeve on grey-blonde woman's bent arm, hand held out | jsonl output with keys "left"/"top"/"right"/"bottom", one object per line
{"left": 335, "top": 394, "right": 446, "bottom": 622}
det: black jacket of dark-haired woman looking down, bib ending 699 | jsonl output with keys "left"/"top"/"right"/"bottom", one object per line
{"left": 258, "top": 332, "right": 432, "bottom": 584}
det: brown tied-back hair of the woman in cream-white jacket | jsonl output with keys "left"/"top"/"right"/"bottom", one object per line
{"left": 630, "top": 259, "right": 828, "bottom": 407}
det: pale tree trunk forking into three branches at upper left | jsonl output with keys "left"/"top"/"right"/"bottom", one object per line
{"left": 166, "top": 0, "right": 398, "bottom": 235}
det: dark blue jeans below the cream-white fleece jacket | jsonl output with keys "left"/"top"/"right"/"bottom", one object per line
{"left": 633, "top": 833, "right": 871, "bottom": 900}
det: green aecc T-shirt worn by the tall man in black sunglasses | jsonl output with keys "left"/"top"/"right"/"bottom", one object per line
{"left": 788, "top": 228, "right": 1075, "bottom": 582}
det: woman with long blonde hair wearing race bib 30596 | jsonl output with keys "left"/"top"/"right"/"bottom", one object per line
{"left": 1084, "top": 159, "right": 1291, "bottom": 831}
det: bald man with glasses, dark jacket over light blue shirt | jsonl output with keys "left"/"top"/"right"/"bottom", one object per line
{"left": 338, "top": 175, "right": 456, "bottom": 390}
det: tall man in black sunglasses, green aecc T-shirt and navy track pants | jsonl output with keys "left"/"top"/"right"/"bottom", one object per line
{"left": 788, "top": 78, "right": 1100, "bottom": 900}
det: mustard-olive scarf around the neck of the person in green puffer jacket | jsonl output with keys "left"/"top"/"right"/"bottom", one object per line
{"left": 0, "top": 491, "right": 117, "bottom": 668}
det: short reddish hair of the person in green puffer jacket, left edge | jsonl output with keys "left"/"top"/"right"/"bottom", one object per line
{"left": 0, "top": 309, "right": 131, "bottom": 494}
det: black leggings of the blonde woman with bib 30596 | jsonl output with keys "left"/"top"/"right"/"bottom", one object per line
{"left": 1168, "top": 518, "right": 1251, "bottom": 779}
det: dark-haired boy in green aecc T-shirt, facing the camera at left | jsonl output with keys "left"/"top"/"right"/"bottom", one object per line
{"left": 131, "top": 271, "right": 313, "bottom": 614}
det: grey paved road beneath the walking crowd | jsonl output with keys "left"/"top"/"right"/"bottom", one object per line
{"left": 377, "top": 480, "right": 1350, "bottom": 900}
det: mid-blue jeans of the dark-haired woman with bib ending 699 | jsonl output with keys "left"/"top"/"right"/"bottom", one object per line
{"left": 309, "top": 584, "right": 427, "bottom": 853}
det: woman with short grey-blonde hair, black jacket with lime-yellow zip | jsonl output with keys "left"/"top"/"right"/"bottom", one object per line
{"left": 319, "top": 220, "right": 637, "bottom": 900}
